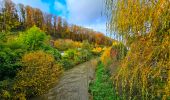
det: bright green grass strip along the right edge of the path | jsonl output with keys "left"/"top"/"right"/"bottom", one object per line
{"left": 89, "top": 62, "right": 118, "bottom": 100}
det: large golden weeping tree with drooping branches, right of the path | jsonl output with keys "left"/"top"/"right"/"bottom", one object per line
{"left": 106, "top": 0, "right": 170, "bottom": 100}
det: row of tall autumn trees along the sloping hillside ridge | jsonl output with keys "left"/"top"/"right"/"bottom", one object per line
{"left": 0, "top": 0, "right": 112, "bottom": 45}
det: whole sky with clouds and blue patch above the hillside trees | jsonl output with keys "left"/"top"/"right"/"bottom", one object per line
{"left": 12, "top": 0, "right": 106, "bottom": 33}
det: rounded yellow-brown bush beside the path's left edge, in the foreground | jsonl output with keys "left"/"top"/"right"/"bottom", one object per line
{"left": 14, "top": 51, "right": 62, "bottom": 99}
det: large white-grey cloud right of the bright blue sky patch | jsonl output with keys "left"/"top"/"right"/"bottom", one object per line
{"left": 66, "top": 0, "right": 106, "bottom": 33}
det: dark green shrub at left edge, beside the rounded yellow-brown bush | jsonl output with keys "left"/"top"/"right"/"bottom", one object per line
{"left": 0, "top": 38, "right": 26, "bottom": 80}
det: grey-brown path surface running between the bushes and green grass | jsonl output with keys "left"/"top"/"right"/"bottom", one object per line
{"left": 32, "top": 60, "right": 96, "bottom": 100}
